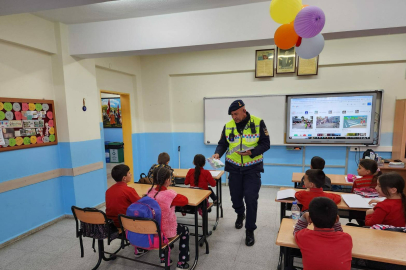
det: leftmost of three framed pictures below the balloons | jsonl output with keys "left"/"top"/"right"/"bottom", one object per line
{"left": 255, "top": 49, "right": 275, "bottom": 78}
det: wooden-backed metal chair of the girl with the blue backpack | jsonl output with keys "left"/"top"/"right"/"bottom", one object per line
{"left": 116, "top": 215, "right": 179, "bottom": 270}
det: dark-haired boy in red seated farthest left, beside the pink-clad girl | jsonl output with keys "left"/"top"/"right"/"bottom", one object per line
{"left": 106, "top": 164, "right": 148, "bottom": 257}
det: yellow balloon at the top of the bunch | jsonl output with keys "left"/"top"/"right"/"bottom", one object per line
{"left": 269, "top": 0, "right": 302, "bottom": 24}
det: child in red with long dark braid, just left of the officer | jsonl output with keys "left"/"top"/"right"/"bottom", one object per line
{"left": 185, "top": 154, "right": 217, "bottom": 203}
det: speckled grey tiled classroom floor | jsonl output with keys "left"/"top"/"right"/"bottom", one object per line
{"left": 0, "top": 187, "right": 362, "bottom": 270}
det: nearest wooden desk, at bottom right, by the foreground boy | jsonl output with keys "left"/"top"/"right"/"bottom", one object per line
{"left": 276, "top": 218, "right": 406, "bottom": 265}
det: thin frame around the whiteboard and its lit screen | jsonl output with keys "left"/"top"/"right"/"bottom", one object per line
{"left": 203, "top": 89, "right": 385, "bottom": 147}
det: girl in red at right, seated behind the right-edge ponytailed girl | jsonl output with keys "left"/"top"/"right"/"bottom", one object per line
{"left": 351, "top": 159, "right": 382, "bottom": 192}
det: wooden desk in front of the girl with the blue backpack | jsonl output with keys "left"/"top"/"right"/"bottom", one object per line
{"left": 128, "top": 183, "right": 211, "bottom": 270}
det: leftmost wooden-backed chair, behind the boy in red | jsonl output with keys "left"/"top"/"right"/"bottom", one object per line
{"left": 71, "top": 206, "right": 124, "bottom": 270}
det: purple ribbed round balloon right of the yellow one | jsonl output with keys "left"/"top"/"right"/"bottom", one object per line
{"left": 294, "top": 6, "right": 326, "bottom": 38}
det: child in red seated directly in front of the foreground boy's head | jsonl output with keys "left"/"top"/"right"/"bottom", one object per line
{"left": 295, "top": 169, "right": 341, "bottom": 212}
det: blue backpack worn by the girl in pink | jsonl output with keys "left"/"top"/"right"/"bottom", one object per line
{"left": 126, "top": 196, "right": 168, "bottom": 249}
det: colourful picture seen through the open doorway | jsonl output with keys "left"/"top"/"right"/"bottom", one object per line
{"left": 102, "top": 98, "right": 123, "bottom": 128}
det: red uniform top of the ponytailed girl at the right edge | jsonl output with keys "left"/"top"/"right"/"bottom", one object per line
{"left": 365, "top": 199, "right": 406, "bottom": 227}
